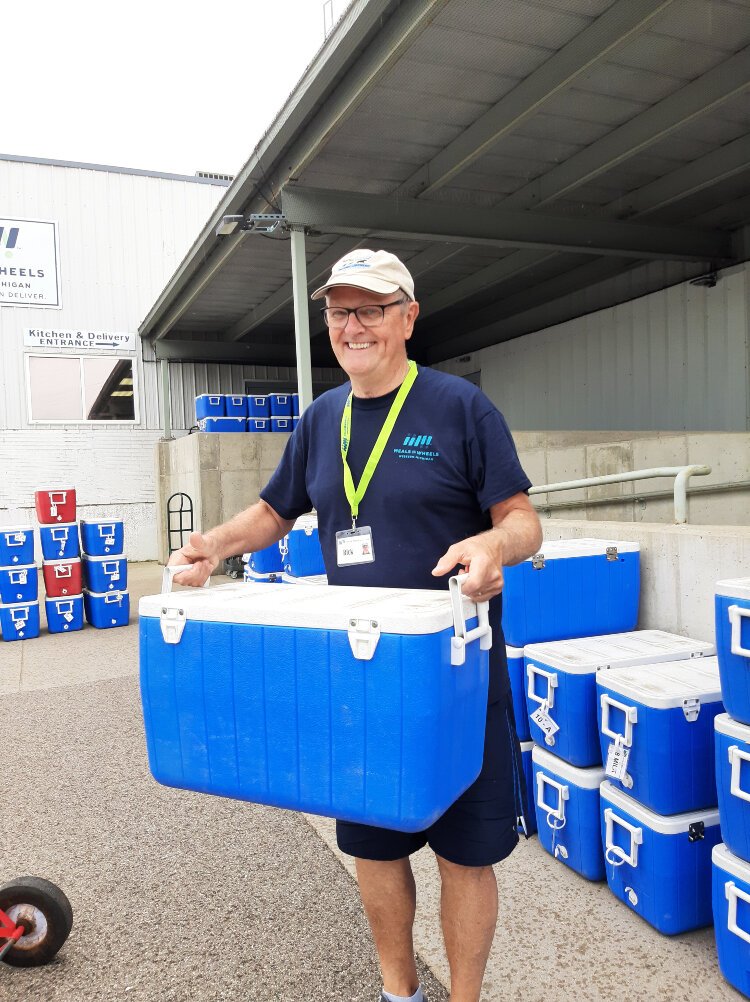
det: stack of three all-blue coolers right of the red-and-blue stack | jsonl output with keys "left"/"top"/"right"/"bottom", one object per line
{"left": 81, "top": 519, "right": 130, "bottom": 629}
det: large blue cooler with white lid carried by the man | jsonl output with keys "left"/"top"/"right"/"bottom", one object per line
{"left": 139, "top": 583, "right": 491, "bottom": 832}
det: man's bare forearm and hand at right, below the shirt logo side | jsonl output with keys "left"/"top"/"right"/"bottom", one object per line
{"left": 433, "top": 492, "right": 542, "bottom": 602}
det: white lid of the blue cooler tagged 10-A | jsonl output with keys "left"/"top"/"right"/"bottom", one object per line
{"left": 524, "top": 629, "right": 716, "bottom": 674}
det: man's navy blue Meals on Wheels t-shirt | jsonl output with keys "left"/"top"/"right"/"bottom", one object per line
{"left": 260, "top": 367, "right": 531, "bottom": 702}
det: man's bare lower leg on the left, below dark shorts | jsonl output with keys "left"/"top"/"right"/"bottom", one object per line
{"left": 356, "top": 857, "right": 418, "bottom": 998}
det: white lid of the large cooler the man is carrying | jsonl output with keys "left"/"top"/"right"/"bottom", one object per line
{"left": 138, "top": 581, "right": 476, "bottom": 635}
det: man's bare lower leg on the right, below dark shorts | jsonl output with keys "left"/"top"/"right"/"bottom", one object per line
{"left": 436, "top": 856, "right": 498, "bottom": 1002}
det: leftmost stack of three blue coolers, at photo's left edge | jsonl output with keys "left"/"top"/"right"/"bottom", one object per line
{"left": 0, "top": 525, "right": 39, "bottom": 641}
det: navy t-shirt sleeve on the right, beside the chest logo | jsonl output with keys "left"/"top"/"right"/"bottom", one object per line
{"left": 469, "top": 407, "right": 532, "bottom": 511}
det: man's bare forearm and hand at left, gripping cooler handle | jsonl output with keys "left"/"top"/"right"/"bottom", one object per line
{"left": 169, "top": 501, "right": 294, "bottom": 588}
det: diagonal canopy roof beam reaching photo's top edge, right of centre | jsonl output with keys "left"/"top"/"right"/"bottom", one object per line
{"left": 398, "top": 0, "right": 674, "bottom": 196}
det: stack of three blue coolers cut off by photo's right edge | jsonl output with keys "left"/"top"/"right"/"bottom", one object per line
{"left": 713, "top": 577, "right": 750, "bottom": 995}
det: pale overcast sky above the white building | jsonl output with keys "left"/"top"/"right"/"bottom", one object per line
{"left": 0, "top": 0, "right": 348, "bottom": 174}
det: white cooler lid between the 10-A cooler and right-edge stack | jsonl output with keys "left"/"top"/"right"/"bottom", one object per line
{"left": 597, "top": 657, "right": 721, "bottom": 709}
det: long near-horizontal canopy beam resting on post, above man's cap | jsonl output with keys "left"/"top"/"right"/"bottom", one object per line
{"left": 281, "top": 187, "right": 732, "bottom": 261}
